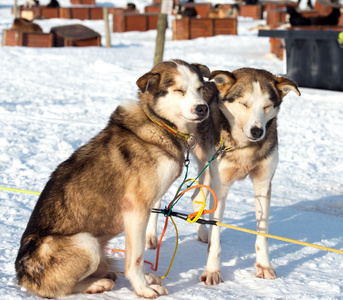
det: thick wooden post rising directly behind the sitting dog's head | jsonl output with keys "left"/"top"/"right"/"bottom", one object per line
{"left": 154, "top": 0, "right": 172, "bottom": 65}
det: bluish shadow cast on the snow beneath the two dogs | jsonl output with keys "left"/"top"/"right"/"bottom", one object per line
{"left": 106, "top": 196, "right": 343, "bottom": 295}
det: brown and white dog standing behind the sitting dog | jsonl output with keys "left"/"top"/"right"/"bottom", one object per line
{"left": 193, "top": 68, "right": 300, "bottom": 285}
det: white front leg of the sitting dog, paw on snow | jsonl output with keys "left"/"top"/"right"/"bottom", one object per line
{"left": 123, "top": 202, "right": 168, "bottom": 298}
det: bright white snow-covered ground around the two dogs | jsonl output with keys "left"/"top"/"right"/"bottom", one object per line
{"left": 0, "top": 0, "right": 343, "bottom": 300}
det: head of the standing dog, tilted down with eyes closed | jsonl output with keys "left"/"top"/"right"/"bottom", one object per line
{"left": 210, "top": 68, "right": 300, "bottom": 142}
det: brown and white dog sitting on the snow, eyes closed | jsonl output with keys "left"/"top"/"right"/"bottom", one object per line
{"left": 15, "top": 60, "right": 209, "bottom": 298}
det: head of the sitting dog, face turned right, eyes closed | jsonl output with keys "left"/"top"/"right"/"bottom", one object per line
{"left": 136, "top": 60, "right": 210, "bottom": 127}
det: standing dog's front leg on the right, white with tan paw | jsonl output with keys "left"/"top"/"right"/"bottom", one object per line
{"left": 250, "top": 156, "right": 276, "bottom": 279}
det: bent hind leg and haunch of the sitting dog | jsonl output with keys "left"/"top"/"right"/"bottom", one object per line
{"left": 16, "top": 233, "right": 114, "bottom": 298}
